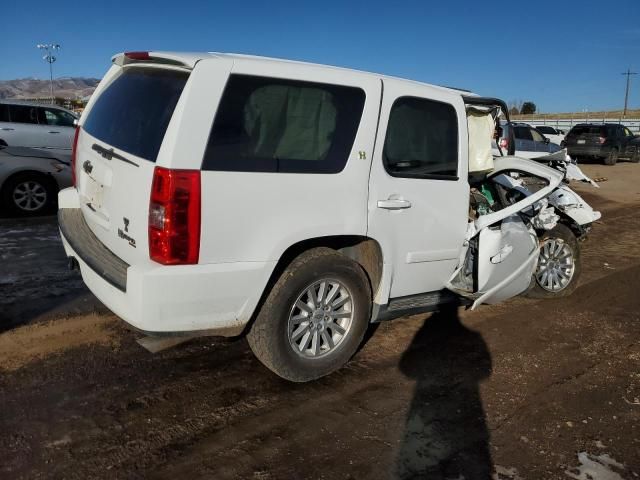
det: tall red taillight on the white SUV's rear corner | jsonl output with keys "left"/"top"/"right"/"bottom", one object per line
{"left": 149, "top": 167, "right": 200, "bottom": 265}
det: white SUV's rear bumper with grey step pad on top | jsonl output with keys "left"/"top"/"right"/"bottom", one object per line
{"left": 59, "top": 189, "right": 275, "bottom": 337}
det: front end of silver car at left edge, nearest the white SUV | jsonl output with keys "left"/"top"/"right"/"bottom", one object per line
{"left": 0, "top": 146, "right": 72, "bottom": 215}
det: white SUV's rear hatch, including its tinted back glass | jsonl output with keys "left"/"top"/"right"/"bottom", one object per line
{"left": 75, "top": 57, "right": 190, "bottom": 264}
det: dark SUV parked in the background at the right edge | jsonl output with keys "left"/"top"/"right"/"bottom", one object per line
{"left": 564, "top": 123, "right": 640, "bottom": 165}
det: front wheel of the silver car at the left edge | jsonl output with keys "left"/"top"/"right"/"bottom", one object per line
{"left": 2, "top": 173, "right": 57, "bottom": 216}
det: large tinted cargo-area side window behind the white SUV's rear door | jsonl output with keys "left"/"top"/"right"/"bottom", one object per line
{"left": 202, "top": 75, "right": 365, "bottom": 173}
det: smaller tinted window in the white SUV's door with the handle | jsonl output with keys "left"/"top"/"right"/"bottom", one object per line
{"left": 382, "top": 97, "right": 458, "bottom": 180}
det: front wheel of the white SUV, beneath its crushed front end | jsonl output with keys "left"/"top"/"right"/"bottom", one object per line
{"left": 527, "top": 223, "right": 582, "bottom": 298}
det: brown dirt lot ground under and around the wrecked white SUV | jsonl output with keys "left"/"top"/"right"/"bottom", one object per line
{"left": 0, "top": 163, "right": 640, "bottom": 480}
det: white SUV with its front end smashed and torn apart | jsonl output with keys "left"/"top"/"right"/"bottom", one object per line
{"left": 58, "top": 52, "right": 599, "bottom": 381}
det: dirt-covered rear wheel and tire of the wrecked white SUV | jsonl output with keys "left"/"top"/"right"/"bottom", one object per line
{"left": 247, "top": 248, "right": 371, "bottom": 382}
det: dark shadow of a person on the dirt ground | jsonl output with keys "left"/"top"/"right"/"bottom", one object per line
{"left": 393, "top": 306, "right": 493, "bottom": 480}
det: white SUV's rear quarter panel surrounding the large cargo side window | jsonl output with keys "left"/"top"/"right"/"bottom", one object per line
{"left": 194, "top": 60, "right": 381, "bottom": 263}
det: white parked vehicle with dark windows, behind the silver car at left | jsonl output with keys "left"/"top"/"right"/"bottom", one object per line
{"left": 0, "top": 100, "right": 78, "bottom": 158}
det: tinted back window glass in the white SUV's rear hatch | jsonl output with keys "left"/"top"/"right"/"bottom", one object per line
{"left": 83, "top": 68, "right": 189, "bottom": 162}
